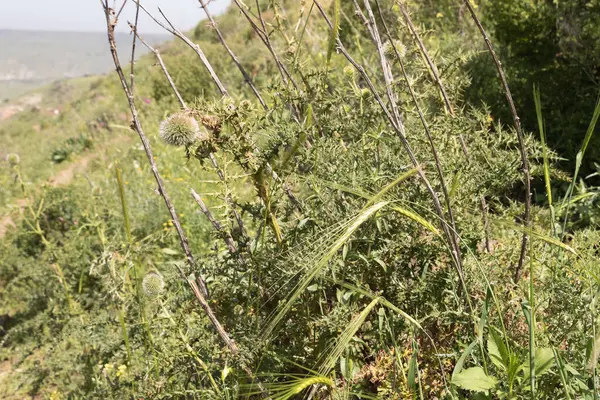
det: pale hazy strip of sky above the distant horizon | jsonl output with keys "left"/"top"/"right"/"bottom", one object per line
{"left": 0, "top": 0, "right": 231, "bottom": 33}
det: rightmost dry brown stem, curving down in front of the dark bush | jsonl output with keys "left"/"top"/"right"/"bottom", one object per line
{"left": 464, "top": 0, "right": 531, "bottom": 283}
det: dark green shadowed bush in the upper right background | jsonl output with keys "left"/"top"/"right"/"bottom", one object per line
{"left": 467, "top": 0, "right": 600, "bottom": 177}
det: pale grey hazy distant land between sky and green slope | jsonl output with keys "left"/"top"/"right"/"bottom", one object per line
{"left": 0, "top": 29, "right": 170, "bottom": 101}
